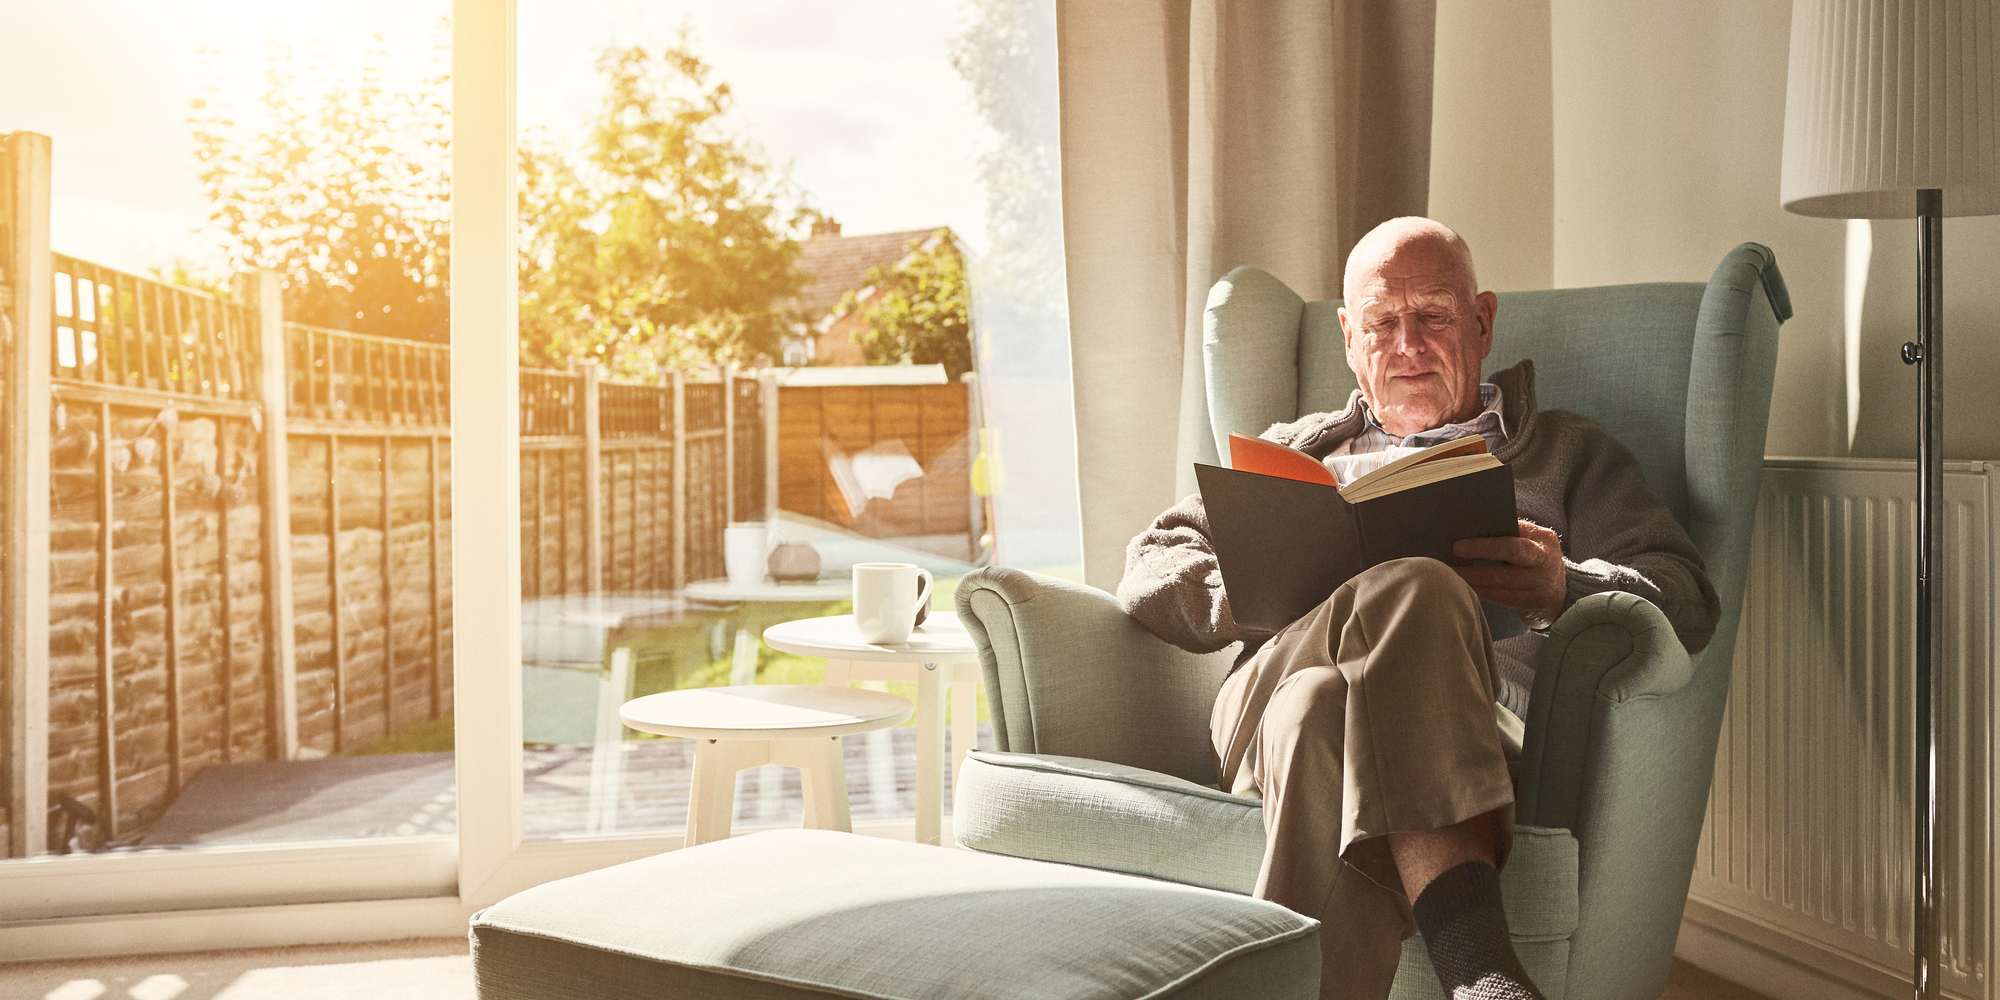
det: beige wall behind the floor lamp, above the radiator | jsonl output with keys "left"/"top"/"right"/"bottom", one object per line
{"left": 1544, "top": 0, "right": 2000, "bottom": 458}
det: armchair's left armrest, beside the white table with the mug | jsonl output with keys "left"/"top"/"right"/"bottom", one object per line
{"left": 956, "top": 566, "right": 1236, "bottom": 786}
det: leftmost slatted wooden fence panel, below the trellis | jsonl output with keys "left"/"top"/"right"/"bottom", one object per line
{"left": 50, "top": 400, "right": 270, "bottom": 836}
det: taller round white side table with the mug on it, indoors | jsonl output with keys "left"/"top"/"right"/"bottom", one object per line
{"left": 764, "top": 612, "right": 980, "bottom": 844}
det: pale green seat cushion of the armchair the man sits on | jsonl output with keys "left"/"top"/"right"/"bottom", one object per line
{"left": 952, "top": 750, "right": 1576, "bottom": 942}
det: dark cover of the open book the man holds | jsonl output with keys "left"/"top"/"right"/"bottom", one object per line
{"left": 1194, "top": 464, "right": 1522, "bottom": 638}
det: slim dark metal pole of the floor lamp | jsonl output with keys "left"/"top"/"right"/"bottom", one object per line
{"left": 1902, "top": 188, "right": 1944, "bottom": 1000}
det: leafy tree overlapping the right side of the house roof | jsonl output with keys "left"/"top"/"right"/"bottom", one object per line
{"left": 838, "top": 230, "right": 972, "bottom": 382}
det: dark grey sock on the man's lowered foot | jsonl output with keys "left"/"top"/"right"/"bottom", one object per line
{"left": 1410, "top": 862, "right": 1542, "bottom": 1000}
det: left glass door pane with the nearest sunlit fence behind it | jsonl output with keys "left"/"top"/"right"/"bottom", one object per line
{"left": 0, "top": 0, "right": 456, "bottom": 858}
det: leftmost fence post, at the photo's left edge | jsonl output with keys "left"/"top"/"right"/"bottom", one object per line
{"left": 0, "top": 132, "right": 56, "bottom": 858}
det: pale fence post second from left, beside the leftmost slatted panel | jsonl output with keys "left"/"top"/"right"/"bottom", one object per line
{"left": 236, "top": 270, "right": 298, "bottom": 760}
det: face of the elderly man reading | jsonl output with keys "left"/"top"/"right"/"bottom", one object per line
{"left": 1340, "top": 242, "right": 1498, "bottom": 436}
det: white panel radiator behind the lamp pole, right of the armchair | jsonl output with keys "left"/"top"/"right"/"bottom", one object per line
{"left": 1680, "top": 460, "right": 2000, "bottom": 1000}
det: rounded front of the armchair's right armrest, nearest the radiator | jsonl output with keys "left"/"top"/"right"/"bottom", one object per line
{"left": 1516, "top": 592, "right": 1708, "bottom": 830}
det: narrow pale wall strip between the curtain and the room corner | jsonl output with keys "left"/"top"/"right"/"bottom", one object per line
{"left": 1430, "top": 0, "right": 1556, "bottom": 292}
